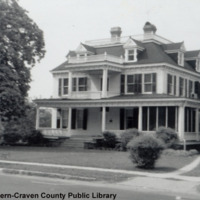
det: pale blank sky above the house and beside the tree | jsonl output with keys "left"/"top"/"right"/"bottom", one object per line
{"left": 18, "top": 0, "right": 200, "bottom": 99}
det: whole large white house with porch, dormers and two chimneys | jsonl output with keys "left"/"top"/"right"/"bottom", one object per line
{"left": 35, "top": 22, "right": 200, "bottom": 141}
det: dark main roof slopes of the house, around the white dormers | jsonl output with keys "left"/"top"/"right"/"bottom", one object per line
{"left": 52, "top": 40, "right": 195, "bottom": 71}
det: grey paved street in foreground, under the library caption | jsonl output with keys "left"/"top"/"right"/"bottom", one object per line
{"left": 0, "top": 174, "right": 197, "bottom": 200}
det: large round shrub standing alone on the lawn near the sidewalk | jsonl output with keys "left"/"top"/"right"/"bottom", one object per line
{"left": 128, "top": 135, "right": 164, "bottom": 169}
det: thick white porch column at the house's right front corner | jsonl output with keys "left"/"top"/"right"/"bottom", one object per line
{"left": 178, "top": 106, "right": 185, "bottom": 140}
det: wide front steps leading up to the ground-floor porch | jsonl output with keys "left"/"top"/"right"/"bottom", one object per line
{"left": 60, "top": 136, "right": 93, "bottom": 149}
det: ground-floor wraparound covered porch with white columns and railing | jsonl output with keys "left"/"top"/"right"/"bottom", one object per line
{"left": 36, "top": 97, "right": 200, "bottom": 141}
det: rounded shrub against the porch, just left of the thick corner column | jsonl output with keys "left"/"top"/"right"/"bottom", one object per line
{"left": 156, "top": 127, "right": 178, "bottom": 148}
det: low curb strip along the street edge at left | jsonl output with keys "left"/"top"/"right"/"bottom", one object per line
{"left": 0, "top": 168, "right": 96, "bottom": 181}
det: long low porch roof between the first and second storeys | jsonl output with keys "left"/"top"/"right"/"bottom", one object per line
{"left": 34, "top": 94, "right": 200, "bottom": 108}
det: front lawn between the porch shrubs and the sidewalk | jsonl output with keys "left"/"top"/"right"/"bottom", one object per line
{"left": 0, "top": 146, "right": 196, "bottom": 173}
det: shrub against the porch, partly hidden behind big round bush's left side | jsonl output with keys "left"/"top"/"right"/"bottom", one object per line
{"left": 121, "top": 129, "right": 142, "bottom": 151}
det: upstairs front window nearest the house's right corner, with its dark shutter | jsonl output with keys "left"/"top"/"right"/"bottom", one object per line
{"left": 144, "top": 73, "right": 156, "bottom": 92}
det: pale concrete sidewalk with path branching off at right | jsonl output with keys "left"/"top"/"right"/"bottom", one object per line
{"left": 0, "top": 156, "right": 200, "bottom": 182}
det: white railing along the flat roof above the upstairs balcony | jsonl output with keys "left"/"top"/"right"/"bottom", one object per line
{"left": 68, "top": 53, "right": 124, "bottom": 64}
